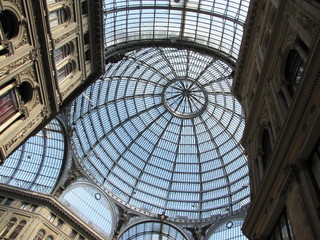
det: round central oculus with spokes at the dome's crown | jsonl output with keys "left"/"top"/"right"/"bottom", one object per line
{"left": 162, "top": 78, "right": 208, "bottom": 118}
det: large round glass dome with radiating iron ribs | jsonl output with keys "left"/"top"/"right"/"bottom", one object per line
{"left": 69, "top": 48, "right": 249, "bottom": 219}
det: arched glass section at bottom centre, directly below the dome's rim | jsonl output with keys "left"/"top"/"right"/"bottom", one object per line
{"left": 119, "top": 222, "right": 188, "bottom": 240}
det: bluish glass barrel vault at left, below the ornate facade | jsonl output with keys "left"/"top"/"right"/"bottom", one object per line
{"left": 0, "top": 119, "right": 65, "bottom": 194}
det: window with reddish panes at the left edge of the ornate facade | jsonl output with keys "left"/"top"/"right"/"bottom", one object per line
{"left": 0, "top": 88, "right": 18, "bottom": 125}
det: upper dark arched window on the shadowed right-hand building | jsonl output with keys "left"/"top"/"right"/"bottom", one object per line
{"left": 285, "top": 49, "right": 304, "bottom": 95}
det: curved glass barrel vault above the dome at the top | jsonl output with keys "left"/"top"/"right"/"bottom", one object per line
{"left": 104, "top": 0, "right": 249, "bottom": 60}
